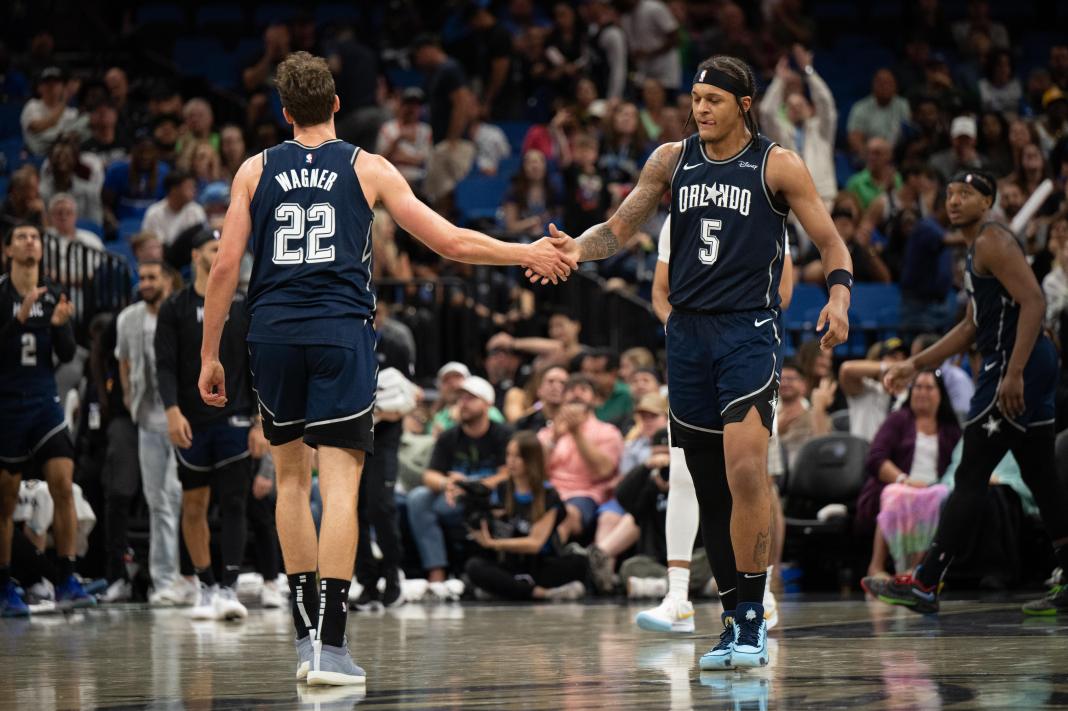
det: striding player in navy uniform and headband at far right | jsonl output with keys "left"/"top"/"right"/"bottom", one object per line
{"left": 863, "top": 171, "right": 1068, "bottom": 615}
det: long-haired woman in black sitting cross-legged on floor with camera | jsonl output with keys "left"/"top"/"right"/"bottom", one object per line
{"left": 465, "top": 432, "right": 586, "bottom": 600}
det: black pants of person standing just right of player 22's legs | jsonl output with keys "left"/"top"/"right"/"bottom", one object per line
{"left": 356, "top": 437, "right": 401, "bottom": 587}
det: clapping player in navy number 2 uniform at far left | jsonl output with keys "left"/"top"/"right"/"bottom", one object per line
{"left": 0, "top": 224, "right": 96, "bottom": 617}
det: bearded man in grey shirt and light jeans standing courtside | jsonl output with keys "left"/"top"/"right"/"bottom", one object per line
{"left": 115, "top": 262, "right": 187, "bottom": 604}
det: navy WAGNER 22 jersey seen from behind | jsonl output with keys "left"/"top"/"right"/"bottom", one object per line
{"left": 249, "top": 139, "right": 375, "bottom": 348}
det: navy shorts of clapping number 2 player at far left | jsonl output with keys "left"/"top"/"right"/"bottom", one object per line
{"left": 0, "top": 394, "right": 74, "bottom": 474}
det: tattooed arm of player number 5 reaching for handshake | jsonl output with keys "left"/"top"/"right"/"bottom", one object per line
{"left": 528, "top": 142, "right": 682, "bottom": 280}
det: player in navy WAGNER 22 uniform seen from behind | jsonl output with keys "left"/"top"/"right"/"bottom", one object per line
{"left": 200, "top": 52, "right": 576, "bottom": 684}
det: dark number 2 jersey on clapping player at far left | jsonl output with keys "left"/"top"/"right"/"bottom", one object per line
{"left": 0, "top": 274, "right": 75, "bottom": 398}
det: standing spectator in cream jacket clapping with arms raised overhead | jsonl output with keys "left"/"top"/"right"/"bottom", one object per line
{"left": 760, "top": 45, "right": 838, "bottom": 205}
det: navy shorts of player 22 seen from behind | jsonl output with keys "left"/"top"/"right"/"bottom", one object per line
{"left": 249, "top": 323, "right": 378, "bottom": 454}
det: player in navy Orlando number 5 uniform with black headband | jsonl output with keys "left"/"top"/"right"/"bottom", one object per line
{"left": 542, "top": 56, "right": 852, "bottom": 669}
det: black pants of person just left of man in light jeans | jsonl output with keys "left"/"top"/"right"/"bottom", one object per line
{"left": 101, "top": 415, "right": 141, "bottom": 583}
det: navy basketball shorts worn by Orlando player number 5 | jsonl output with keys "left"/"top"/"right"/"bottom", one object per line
{"left": 666, "top": 309, "right": 782, "bottom": 447}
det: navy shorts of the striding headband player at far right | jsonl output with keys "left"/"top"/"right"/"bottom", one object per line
{"left": 964, "top": 335, "right": 1058, "bottom": 433}
